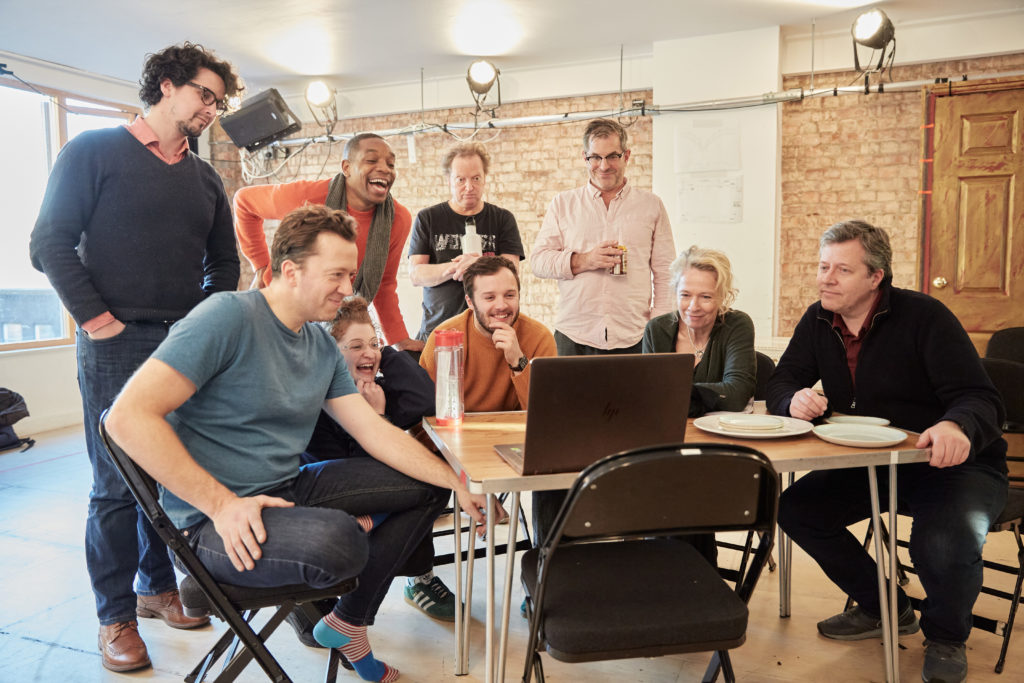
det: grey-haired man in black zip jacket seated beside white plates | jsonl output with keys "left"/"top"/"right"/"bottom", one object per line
{"left": 768, "top": 220, "right": 1007, "bottom": 682}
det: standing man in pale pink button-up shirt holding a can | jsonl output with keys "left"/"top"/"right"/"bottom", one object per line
{"left": 529, "top": 119, "right": 676, "bottom": 355}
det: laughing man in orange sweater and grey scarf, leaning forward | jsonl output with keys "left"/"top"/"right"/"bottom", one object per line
{"left": 234, "top": 133, "right": 423, "bottom": 351}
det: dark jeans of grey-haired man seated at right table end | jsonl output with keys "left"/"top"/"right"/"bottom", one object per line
{"left": 778, "top": 462, "right": 1007, "bottom": 642}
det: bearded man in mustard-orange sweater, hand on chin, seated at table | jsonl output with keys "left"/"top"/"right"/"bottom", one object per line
{"left": 420, "top": 256, "right": 555, "bottom": 413}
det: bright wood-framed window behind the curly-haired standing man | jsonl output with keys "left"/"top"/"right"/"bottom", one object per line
{"left": 0, "top": 79, "right": 138, "bottom": 351}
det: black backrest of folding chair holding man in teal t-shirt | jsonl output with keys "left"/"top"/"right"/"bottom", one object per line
{"left": 99, "top": 411, "right": 229, "bottom": 589}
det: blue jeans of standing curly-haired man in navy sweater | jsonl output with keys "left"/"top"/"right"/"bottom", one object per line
{"left": 77, "top": 323, "right": 177, "bottom": 626}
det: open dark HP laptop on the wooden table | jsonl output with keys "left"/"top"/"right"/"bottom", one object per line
{"left": 495, "top": 353, "right": 693, "bottom": 474}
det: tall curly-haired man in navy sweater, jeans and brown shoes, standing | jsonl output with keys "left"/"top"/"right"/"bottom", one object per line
{"left": 30, "top": 42, "right": 242, "bottom": 671}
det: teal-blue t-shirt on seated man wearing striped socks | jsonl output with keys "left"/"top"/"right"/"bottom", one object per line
{"left": 153, "top": 290, "right": 356, "bottom": 528}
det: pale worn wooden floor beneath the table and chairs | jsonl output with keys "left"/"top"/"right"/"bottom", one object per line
{"left": 0, "top": 428, "right": 1024, "bottom": 683}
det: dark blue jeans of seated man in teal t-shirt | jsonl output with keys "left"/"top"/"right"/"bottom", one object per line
{"left": 186, "top": 458, "right": 452, "bottom": 626}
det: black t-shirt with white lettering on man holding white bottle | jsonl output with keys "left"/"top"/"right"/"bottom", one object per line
{"left": 409, "top": 202, "right": 525, "bottom": 341}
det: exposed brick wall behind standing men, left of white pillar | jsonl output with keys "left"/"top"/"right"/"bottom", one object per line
{"left": 212, "top": 90, "right": 652, "bottom": 326}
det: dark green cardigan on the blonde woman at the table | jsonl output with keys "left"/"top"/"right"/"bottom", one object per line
{"left": 643, "top": 310, "right": 757, "bottom": 417}
